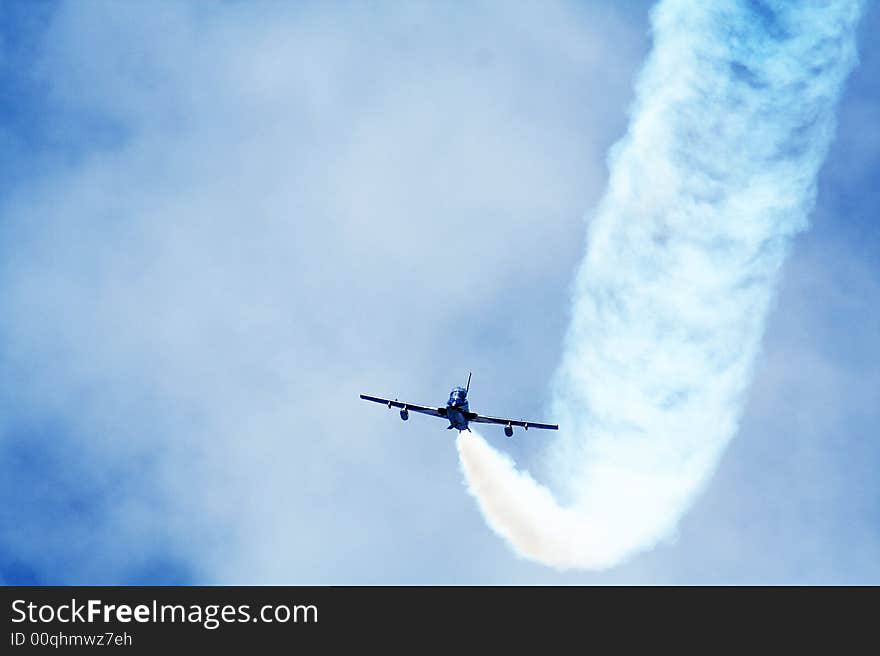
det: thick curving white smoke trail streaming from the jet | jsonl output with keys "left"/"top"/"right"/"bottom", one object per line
{"left": 458, "top": 0, "right": 861, "bottom": 568}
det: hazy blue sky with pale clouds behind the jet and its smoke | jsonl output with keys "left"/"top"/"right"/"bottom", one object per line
{"left": 0, "top": 2, "right": 880, "bottom": 584}
